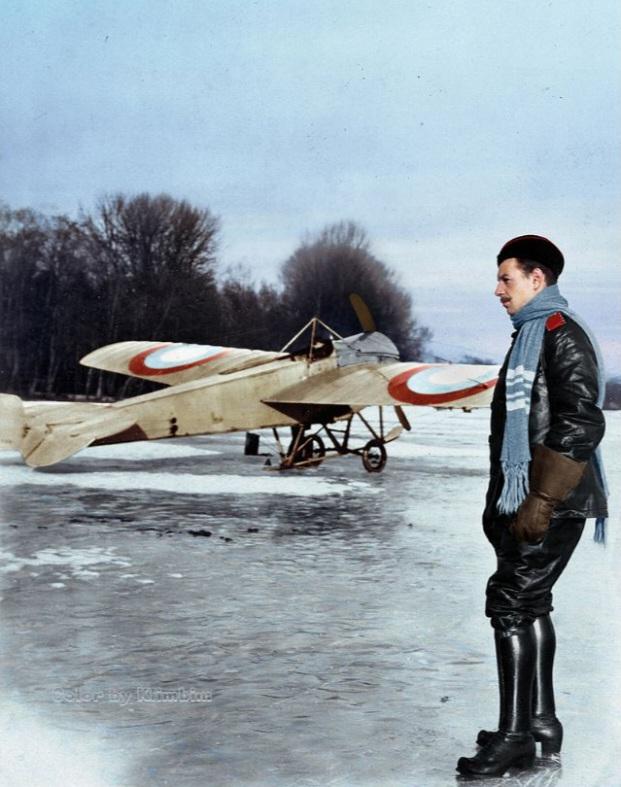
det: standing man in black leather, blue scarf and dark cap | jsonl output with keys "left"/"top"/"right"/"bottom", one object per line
{"left": 457, "top": 235, "right": 607, "bottom": 776}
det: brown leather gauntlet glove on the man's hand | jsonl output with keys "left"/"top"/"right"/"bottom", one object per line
{"left": 511, "top": 444, "right": 586, "bottom": 543}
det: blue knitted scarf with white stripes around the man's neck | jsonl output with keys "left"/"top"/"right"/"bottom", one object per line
{"left": 498, "top": 284, "right": 608, "bottom": 541}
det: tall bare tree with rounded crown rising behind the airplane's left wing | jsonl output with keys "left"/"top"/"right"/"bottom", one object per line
{"left": 82, "top": 194, "right": 220, "bottom": 394}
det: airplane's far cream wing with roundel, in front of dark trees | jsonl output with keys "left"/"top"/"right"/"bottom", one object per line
{"left": 80, "top": 342, "right": 290, "bottom": 385}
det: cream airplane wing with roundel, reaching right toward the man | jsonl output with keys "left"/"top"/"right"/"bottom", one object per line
{"left": 264, "top": 363, "right": 500, "bottom": 412}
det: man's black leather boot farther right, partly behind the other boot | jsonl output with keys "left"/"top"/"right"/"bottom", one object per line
{"left": 477, "top": 614, "right": 563, "bottom": 757}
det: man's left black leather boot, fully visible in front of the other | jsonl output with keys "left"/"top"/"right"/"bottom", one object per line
{"left": 457, "top": 626, "right": 535, "bottom": 776}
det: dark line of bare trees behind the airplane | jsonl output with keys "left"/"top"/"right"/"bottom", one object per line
{"left": 0, "top": 194, "right": 431, "bottom": 398}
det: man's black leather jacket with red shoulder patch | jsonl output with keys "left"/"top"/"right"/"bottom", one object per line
{"left": 484, "top": 314, "right": 607, "bottom": 521}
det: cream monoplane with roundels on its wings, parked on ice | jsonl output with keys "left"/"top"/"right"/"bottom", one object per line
{"left": 0, "top": 296, "right": 498, "bottom": 472}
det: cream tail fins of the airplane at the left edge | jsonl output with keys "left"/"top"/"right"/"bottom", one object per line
{"left": 0, "top": 394, "right": 135, "bottom": 467}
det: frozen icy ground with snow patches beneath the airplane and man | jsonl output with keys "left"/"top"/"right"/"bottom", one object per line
{"left": 0, "top": 410, "right": 621, "bottom": 787}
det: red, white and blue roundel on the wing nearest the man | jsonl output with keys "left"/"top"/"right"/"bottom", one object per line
{"left": 388, "top": 365, "right": 498, "bottom": 405}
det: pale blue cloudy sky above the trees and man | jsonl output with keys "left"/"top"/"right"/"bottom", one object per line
{"left": 0, "top": 0, "right": 621, "bottom": 373}
